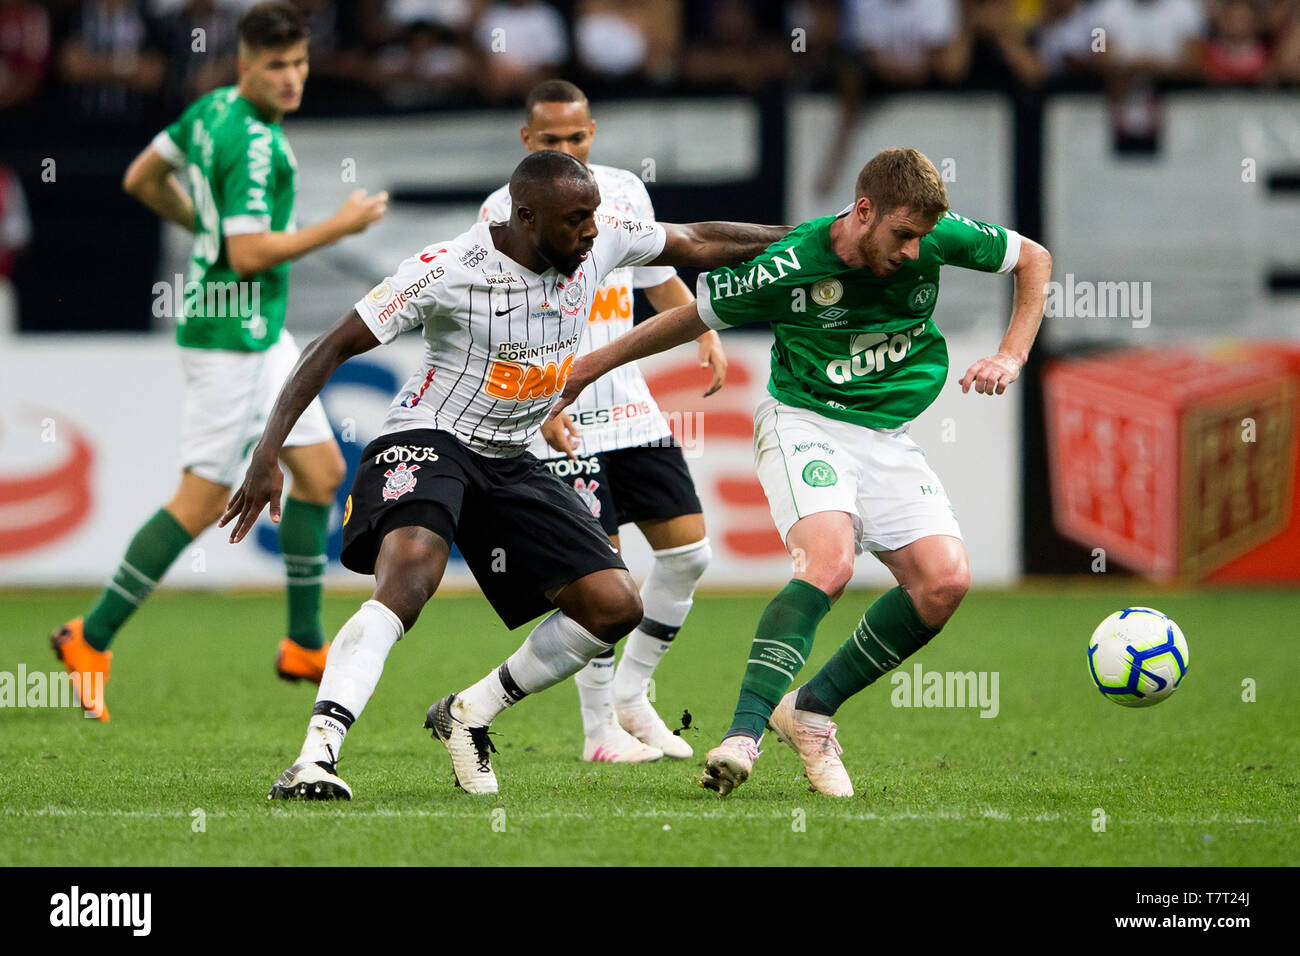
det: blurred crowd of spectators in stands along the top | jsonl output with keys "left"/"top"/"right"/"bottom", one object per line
{"left": 0, "top": 0, "right": 1300, "bottom": 126}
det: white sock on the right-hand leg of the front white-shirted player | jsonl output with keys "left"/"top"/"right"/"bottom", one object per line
{"left": 452, "top": 611, "right": 610, "bottom": 727}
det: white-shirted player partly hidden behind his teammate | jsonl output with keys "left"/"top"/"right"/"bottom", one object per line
{"left": 478, "top": 79, "right": 727, "bottom": 762}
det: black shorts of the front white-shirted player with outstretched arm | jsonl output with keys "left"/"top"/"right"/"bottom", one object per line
{"left": 342, "top": 428, "right": 627, "bottom": 628}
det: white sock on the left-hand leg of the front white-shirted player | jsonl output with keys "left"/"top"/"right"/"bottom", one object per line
{"left": 298, "top": 600, "right": 406, "bottom": 763}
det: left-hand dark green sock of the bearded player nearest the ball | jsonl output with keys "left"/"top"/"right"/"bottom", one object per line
{"left": 725, "top": 580, "right": 831, "bottom": 740}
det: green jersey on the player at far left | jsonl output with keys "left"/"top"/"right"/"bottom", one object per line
{"left": 153, "top": 86, "right": 298, "bottom": 351}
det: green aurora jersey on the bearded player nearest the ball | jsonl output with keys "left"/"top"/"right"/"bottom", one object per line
{"left": 696, "top": 212, "right": 1021, "bottom": 428}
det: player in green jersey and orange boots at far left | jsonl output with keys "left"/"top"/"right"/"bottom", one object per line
{"left": 51, "top": 3, "right": 387, "bottom": 721}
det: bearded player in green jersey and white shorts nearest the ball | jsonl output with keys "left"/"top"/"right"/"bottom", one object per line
{"left": 551, "top": 148, "right": 1052, "bottom": 796}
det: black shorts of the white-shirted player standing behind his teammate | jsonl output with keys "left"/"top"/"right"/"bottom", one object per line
{"left": 543, "top": 441, "right": 703, "bottom": 535}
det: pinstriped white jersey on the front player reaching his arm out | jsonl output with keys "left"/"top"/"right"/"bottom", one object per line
{"left": 356, "top": 212, "right": 664, "bottom": 458}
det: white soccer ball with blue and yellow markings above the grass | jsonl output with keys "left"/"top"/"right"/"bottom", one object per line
{"left": 1088, "top": 607, "right": 1187, "bottom": 708}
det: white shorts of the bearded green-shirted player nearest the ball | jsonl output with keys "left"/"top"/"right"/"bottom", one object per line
{"left": 754, "top": 398, "right": 962, "bottom": 554}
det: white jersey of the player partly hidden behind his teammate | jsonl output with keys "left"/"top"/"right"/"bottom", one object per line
{"left": 478, "top": 165, "right": 677, "bottom": 458}
